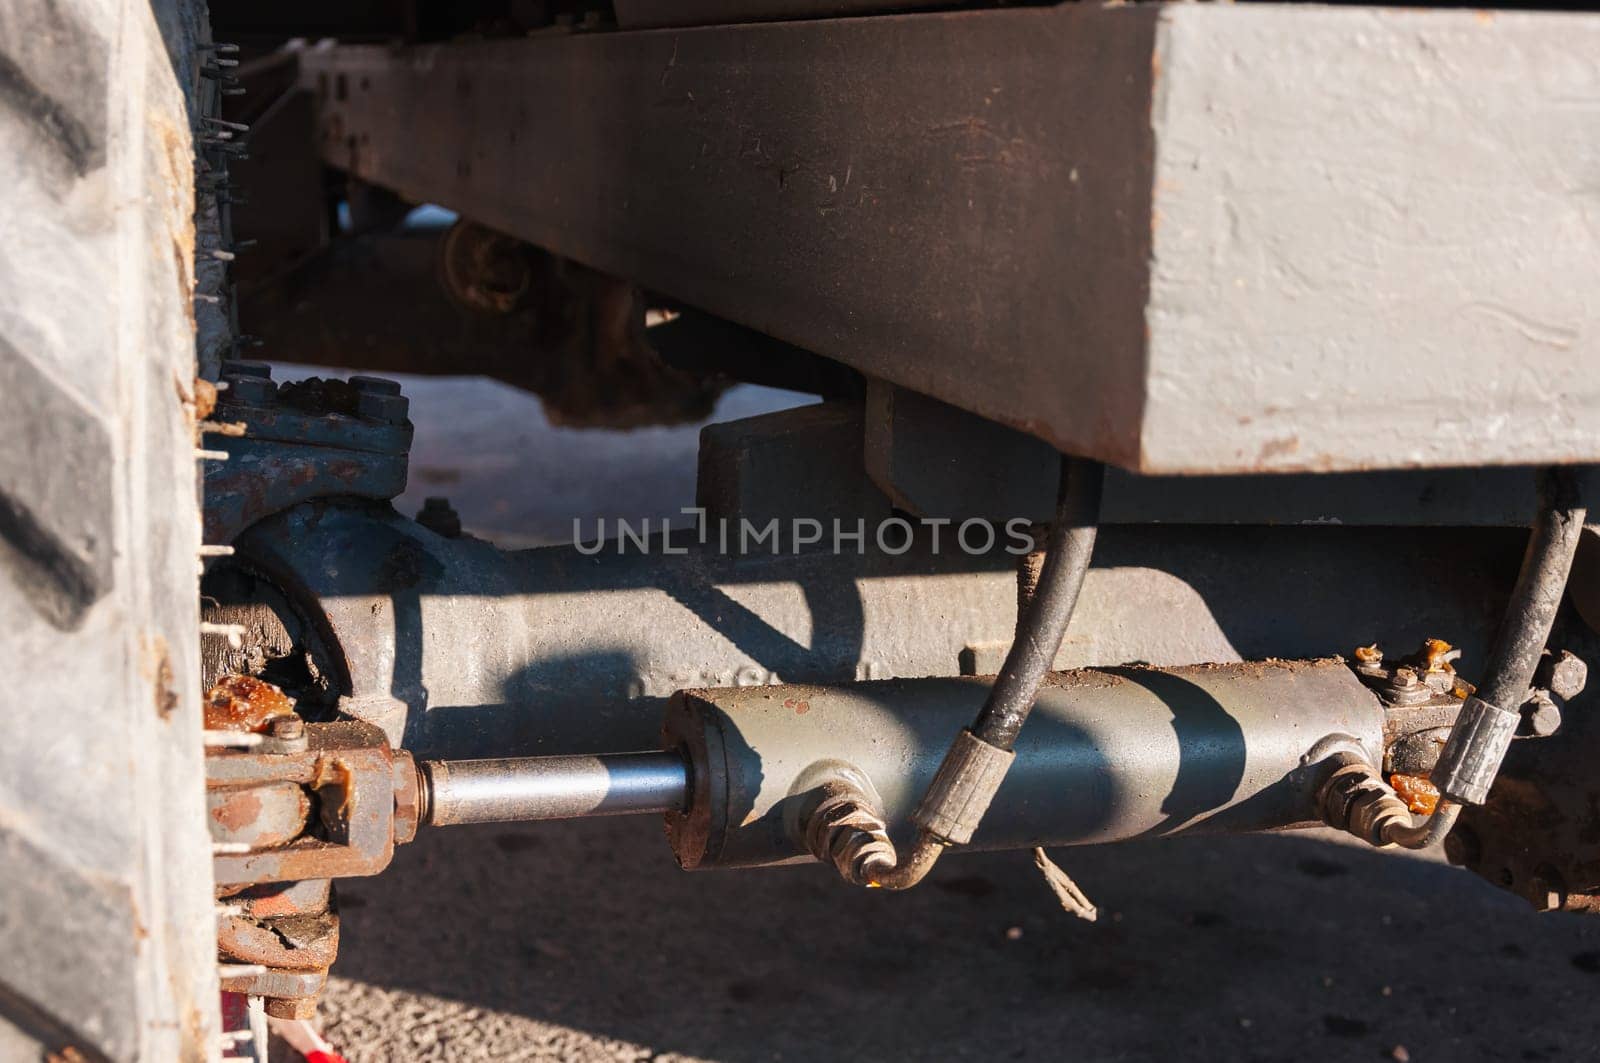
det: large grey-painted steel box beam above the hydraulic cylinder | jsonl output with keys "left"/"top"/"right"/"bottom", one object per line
{"left": 302, "top": 5, "right": 1600, "bottom": 474}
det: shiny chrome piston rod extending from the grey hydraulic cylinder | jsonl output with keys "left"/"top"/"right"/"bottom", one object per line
{"left": 421, "top": 752, "right": 690, "bottom": 826}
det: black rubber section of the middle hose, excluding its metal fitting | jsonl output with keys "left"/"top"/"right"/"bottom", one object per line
{"left": 971, "top": 458, "right": 1106, "bottom": 749}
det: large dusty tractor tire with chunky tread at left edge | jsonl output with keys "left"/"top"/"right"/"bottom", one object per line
{"left": 0, "top": 0, "right": 219, "bottom": 1063}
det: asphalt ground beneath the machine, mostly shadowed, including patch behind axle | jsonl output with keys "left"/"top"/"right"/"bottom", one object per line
{"left": 281, "top": 371, "right": 1600, "bottom": 1063}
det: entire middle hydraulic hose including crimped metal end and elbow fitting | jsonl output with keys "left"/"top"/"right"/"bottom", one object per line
{"left": 864, "top": 456, "right": 1106, "bottom": 890}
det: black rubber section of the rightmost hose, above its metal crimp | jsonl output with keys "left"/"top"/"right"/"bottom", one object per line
{"left": 1478, "top": 467, "right": 1586, "bottom": 712}
